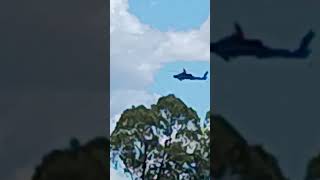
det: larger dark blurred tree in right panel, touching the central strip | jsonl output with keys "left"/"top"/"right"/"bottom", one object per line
{"left": 211, "top": 115, "right": 287, "bottom": 180}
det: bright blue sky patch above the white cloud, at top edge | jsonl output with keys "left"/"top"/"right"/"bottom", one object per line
{"left": 129, "top": 0, "right": 210, "bottom": 31}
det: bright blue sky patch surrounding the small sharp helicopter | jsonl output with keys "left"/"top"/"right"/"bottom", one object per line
{"left": 149, "top": 61, "right": 210, "bottom": 121}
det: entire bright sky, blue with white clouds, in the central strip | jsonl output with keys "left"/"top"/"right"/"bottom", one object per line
{"left": 110, "top": 0, "right": 210, "bottom": 179}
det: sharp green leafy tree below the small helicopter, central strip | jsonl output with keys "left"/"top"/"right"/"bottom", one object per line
{"left": 110, "top": 95, "right": 210, "bottom": 180}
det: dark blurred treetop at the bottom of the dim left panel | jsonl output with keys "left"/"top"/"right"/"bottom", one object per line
{"left": 32, "top": 137, "right": 109, "bottom": 180}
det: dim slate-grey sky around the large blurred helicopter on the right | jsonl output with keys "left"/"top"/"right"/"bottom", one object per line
{"left": 210, "top": 0, "right": 320, "bottom": 180}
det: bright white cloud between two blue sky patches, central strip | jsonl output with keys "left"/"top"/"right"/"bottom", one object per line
{"left": 110, "top": 0, "right": 210, "bottom": 131}
